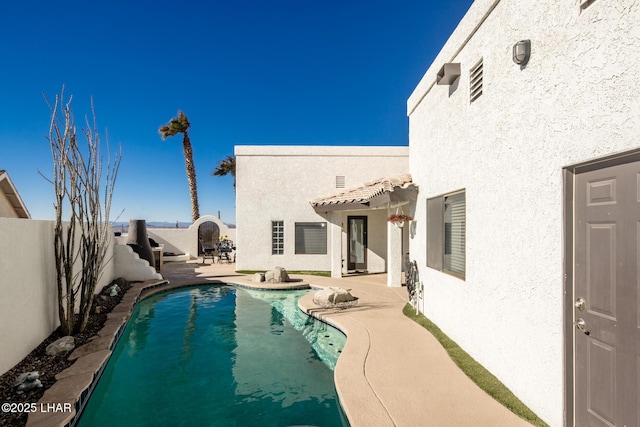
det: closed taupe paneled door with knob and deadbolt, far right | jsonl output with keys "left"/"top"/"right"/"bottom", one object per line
{"left": 573, "top": 162, "right": 640, "bottom": 426}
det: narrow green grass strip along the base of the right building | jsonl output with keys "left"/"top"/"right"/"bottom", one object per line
{"left": 403, "top": 304, "right": 547, "bottom": 426}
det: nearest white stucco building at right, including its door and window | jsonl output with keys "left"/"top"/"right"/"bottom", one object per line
{"left": 407, "top": 0, "right": 640, "bottom": 426}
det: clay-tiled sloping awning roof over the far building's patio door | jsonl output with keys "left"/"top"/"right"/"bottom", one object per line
{"left": 309, "top": 174, "right": 418, "bottom": 212}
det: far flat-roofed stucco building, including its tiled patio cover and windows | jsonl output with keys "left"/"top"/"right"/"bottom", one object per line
{"left": 235, "top": 146, "right": 417, "bottom": 286}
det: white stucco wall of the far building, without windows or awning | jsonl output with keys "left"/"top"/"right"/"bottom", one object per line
{"left": 235, "top": 146, "right": 409, "bottom": 271}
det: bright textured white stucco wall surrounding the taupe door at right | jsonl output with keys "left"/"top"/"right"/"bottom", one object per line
{"left": 408, "top": 0, "right": 640, "bottom": 426}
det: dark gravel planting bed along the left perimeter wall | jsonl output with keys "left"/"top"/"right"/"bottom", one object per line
{"left": 0, "top": 279, "right": 130, "bottom": 427}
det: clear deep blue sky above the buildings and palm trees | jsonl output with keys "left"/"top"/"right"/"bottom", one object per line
{"left": 0, "top": 0, "right": 472, "bottom": 223}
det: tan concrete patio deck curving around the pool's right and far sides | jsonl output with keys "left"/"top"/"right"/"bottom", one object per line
{"left": 162, "top": 261, "right": 529, "bottom": 427}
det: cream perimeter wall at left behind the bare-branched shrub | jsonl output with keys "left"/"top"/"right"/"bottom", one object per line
{"left": 0, "top": 218, "right": 114, "bottom": 374}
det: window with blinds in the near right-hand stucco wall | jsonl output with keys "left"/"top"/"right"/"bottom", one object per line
{"left": 427, "top": 191, "right": 467, "bottom": 278}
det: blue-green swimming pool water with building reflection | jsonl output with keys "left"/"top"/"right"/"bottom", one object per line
{"left": 78, "top": 285, "right": 348, "bottom": 427}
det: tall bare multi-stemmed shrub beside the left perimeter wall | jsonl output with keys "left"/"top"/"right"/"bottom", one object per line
{"left": 45, "top": 86, "right": 122, "bottom": 334}
